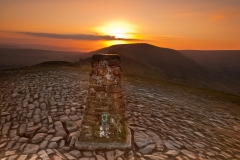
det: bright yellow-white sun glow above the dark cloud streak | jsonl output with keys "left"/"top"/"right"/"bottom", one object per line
{"left": 97, "top": 22, "right": 135, "bottom": 39}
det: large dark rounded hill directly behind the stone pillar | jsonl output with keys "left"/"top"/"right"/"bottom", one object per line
{"left": 82, "top": 43, "right": 240, "bottom": 93}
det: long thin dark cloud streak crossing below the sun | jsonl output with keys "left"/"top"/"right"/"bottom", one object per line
{"left": 17, "top": 32, "right": 138, "bottom": 41}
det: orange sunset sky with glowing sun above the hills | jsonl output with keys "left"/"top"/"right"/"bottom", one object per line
{"left": 0, "top": 0, "right": 240, "bottom": 52}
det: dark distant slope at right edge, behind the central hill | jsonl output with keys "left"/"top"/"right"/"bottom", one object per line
{"left": 180, "top": 50, "right": 240, "bottom": 93}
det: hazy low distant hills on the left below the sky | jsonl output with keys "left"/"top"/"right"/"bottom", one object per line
{"left": 0, "top": 46, "right": 82, "bottom": 69}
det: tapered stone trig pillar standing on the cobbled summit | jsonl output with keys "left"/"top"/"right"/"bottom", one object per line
{"left": 75, "top": 54, "right": 131, "bottom": 149}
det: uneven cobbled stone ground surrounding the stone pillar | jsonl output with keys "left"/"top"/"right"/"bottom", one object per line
{"left": 0, "top": 69, "right": 240, "bottom": 160}
